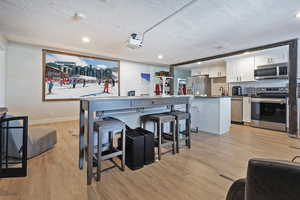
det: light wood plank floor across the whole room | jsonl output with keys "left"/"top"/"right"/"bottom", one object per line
{"left": 0, "top": 122, "right": 300, "bottom": 200}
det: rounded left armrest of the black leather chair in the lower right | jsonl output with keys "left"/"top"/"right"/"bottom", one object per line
{"left": 226, "top": 179, "right": 246, "bottom": 200}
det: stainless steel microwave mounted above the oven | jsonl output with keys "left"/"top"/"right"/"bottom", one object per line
{"left": 254, "top": 63, "right": 288, "bottom": 80}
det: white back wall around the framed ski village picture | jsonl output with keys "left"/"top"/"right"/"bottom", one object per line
{"left": 6, "top": 42, "right": 168, "bottom": 124}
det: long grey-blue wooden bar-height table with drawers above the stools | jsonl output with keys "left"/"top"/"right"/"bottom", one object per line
{"left": 79, "top": 96, "right": 191, "bottom": 185}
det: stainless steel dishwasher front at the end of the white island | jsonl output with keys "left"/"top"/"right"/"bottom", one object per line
{"left": 231, "top": 96, "right": 243, "bottom": 123}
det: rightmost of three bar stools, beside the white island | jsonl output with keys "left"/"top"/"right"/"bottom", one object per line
{"left": 167, "top": 110, "right": 191, "bottom": 153}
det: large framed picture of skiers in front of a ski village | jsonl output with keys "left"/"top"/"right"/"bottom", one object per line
{"left": 43, "top": 50, "right": 119, "bottom": 101}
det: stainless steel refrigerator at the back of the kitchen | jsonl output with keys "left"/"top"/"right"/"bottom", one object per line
{"left": 187, "top": 75, "right": 211, "bottom": 96}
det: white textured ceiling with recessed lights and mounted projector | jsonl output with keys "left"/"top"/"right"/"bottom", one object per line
{"left": 0, "top": 0, "right": 300, "bottom": 64}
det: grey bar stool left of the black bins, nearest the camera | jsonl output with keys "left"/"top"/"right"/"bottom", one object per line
{"left": 93, "top": 118, "right": 126, "bottom": 181}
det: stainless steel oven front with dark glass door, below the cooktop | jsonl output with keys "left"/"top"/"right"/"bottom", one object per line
{"left": 251, "top": 98, "right": 287, "bottom": 131}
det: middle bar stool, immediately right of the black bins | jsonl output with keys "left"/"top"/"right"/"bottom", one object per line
{"left": 141, "top": 114, "right": 176, "bottom": 160}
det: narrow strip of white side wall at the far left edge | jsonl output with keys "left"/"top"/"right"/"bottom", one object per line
{"left": 0, "top": 35, "right": 6, "bottom": 107}
